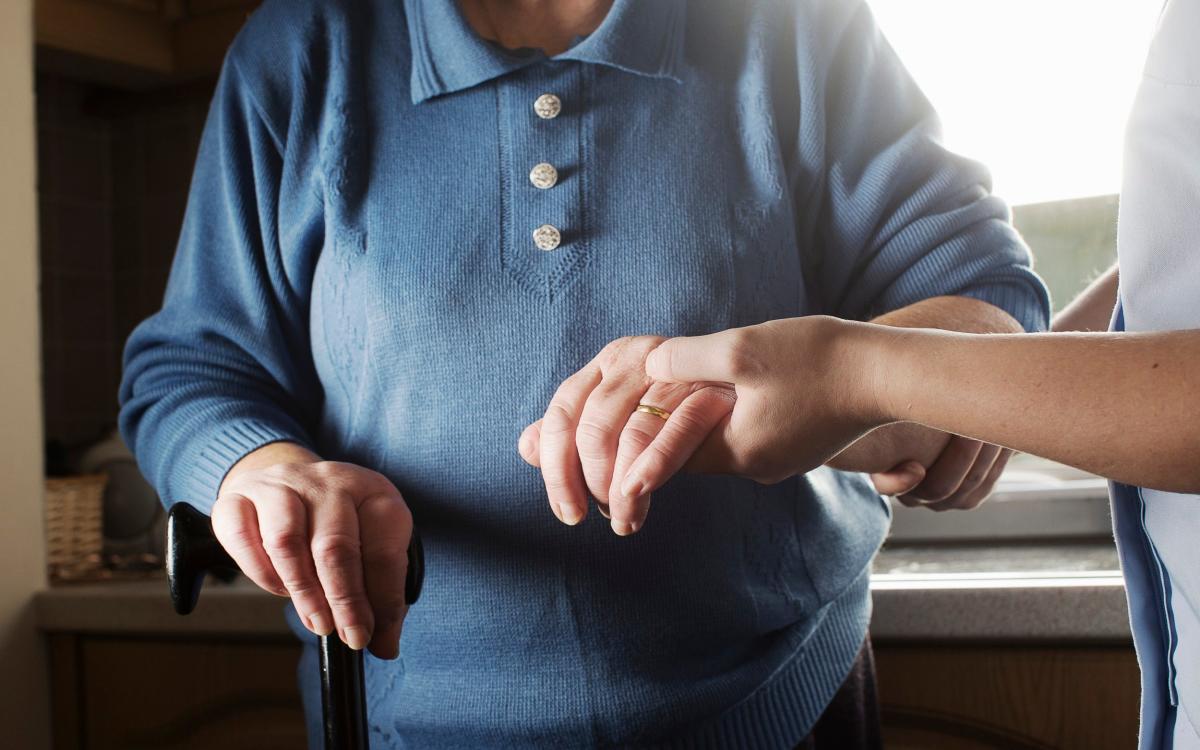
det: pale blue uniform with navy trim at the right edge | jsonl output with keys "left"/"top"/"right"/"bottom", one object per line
{"left": 1112, "top": 0, "right": 1200, "bottom": 750}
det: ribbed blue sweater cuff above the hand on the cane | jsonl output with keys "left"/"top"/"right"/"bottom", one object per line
{"left": 177, "top": 419, "right": 308, "bottom": 514}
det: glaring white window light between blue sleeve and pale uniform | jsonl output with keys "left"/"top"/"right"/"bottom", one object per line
{"left": 869, "top": 0, "right": 1163, "bottom": 205}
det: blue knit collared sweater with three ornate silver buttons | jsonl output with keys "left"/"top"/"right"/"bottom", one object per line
{"left": 121, "top": 0, "right": 1048, "bottom": 748}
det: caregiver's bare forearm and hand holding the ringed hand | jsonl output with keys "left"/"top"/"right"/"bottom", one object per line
{"left": 622, "top": 318, "right": 1200, "bottom": 492}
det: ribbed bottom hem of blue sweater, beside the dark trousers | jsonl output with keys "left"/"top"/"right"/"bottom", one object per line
{"left": 656, "top": 566, "right": 871, "bottom": 750}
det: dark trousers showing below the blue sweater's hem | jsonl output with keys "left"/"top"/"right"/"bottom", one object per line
{"left": 796, "top": 636, "right": 883, "bottom": 750}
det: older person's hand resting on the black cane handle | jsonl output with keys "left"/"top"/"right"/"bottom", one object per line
{"left": 212, "top": 443, "right": 413, "bottom": 659}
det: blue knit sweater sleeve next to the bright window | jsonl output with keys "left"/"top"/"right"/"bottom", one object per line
{"left": 812, "top": 1, "right": 1050, "bottom": 331}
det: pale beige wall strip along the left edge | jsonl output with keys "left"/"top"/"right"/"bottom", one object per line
{"left": 0, "top": 0, "right": 49, "bottom": 750}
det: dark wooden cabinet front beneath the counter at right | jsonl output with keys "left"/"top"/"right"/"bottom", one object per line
{"left": 875, "top": 643, "right": 1140, "bottom": 750}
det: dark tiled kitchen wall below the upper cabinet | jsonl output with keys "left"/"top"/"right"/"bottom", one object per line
{"left": 37, "top": 72, "right": 211, "bottom": 451}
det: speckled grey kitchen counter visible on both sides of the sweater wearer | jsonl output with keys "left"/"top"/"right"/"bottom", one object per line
{"left": 35, "top": 542, "right": 1130, "bottom": 643}
